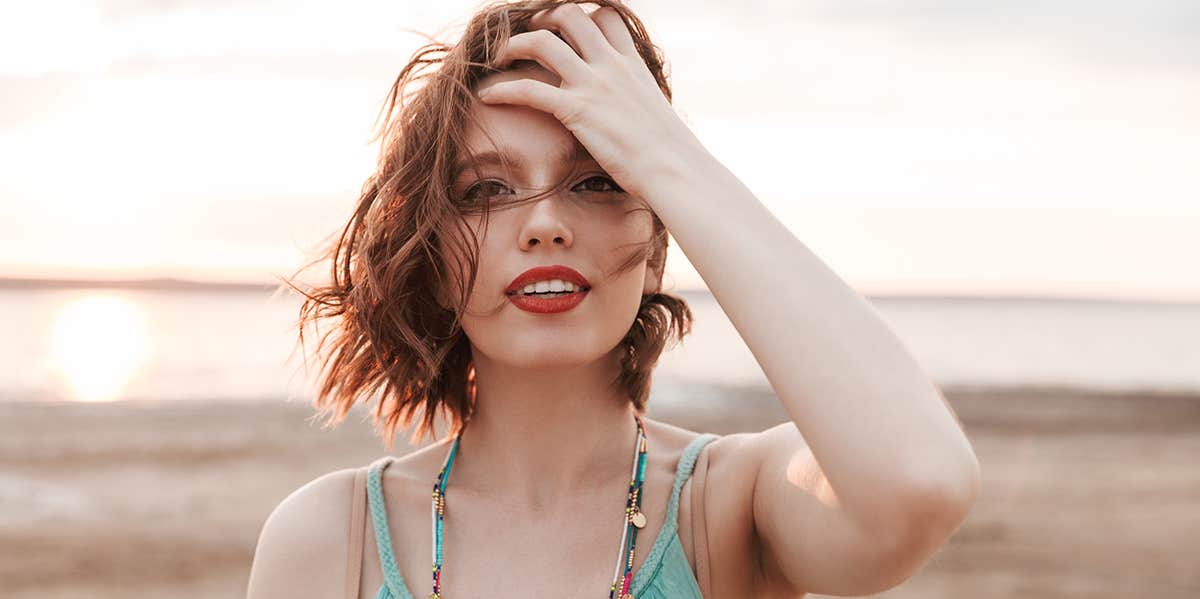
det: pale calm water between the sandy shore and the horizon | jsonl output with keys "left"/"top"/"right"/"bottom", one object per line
{"left": 0, "top": 289, "right": 1200, "bottom": 401}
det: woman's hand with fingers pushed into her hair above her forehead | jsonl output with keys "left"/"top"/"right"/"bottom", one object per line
{"left": 478, "top": 4, "right": 703, "bottom": 202}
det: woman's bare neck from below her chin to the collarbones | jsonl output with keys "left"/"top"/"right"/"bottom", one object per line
{"left": 448, "top": 352, "right": 637, "bottom": 507}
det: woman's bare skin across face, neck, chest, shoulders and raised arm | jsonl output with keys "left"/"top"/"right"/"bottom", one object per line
{"left": 250, "top": 5, "right": 979, "bottom": 598}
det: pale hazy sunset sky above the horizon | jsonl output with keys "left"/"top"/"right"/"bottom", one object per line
{"left": 0, "top": 0, "right": 1200, "bottom": 301}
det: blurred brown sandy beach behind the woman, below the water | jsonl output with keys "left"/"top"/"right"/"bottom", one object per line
{"left": 0, "top": 389, "right": 1200, "bottom": 599}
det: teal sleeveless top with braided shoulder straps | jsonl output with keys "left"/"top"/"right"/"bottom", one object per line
{"left": 367, "top": 433, "right": 718, "bottom": 599}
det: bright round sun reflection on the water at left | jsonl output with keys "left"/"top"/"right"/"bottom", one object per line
{"left": 49, "top": 293, "right": 151, "bottom": 402}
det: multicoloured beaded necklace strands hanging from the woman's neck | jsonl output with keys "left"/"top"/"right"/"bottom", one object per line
{"left": 430, "top": 412, "right": 646, "bottom": 599}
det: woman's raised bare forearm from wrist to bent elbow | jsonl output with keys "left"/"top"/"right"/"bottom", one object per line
{"left": 640, "top": 142, "right": 979, "bottom": 537}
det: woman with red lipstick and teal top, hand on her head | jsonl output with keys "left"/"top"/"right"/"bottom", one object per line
{"left": 250, "top": 1, "right": 979, "bottom": 599}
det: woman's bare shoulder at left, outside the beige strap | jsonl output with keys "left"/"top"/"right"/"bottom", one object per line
{"left": 246, "top": 468, "right": 355, "bottom": 599}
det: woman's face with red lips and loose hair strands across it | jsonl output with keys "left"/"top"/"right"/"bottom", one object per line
{"left": 441, "top": 66, "right": 658, "bottom": 369}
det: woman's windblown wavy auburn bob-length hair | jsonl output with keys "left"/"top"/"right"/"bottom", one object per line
{"left": 280, "top": 0, "right": 691, "bottom": 449}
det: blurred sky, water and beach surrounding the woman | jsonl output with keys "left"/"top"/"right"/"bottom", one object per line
{"left": 0, "top": 0, "right": 1200, "bottom": 599}
